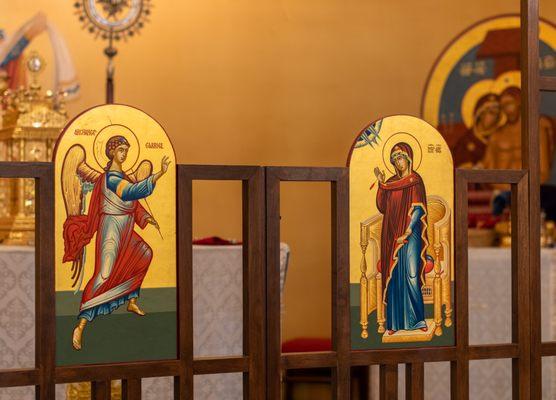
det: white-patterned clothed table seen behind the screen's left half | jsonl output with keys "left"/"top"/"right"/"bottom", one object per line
{"left": 0, "top": 243, "right": 290, "bottom": 400}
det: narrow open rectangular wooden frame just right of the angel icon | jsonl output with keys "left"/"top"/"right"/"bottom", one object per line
{"left": 175, "top": 165, "right": 266, "bottom": 400}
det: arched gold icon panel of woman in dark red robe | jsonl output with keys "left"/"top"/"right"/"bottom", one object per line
{"left": 348, "top": 115, "right": 454, "bottom": 349}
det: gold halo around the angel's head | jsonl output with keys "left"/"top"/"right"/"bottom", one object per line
{"left": 93, "top": 124, "right": 141, "bottom": 172}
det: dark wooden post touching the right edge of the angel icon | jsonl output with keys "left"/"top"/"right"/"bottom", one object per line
{"left": 174, "top": 165, "right": 193, "bottom": 400}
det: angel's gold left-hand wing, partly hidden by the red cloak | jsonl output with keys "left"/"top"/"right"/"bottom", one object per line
{"left": 61, "top": 144, "right": 101, "bottom": 292}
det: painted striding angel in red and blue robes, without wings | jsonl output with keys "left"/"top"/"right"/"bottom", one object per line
{"left": 63, "top": 136, "right": 170, "bottom": 350}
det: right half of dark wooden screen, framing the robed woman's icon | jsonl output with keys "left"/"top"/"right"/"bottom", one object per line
{"left": 266, "top": 167, "right": 530, "bottom": 400}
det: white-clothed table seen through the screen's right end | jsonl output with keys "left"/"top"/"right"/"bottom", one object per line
{"left": 371, "top": 248, "right": 556, "bottom": 400}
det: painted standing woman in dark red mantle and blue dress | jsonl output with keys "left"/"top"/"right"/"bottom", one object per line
{"left": 374, "top": 142, "right": 428, "bottom": 335}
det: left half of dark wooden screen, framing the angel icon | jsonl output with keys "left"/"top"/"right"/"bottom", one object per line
{"left": 0, "top": 163, "right": 266, "bottom": 400}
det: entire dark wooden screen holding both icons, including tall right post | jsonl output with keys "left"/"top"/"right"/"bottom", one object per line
{"left": 0, "top": 0, "right": 556, "bottom": 400}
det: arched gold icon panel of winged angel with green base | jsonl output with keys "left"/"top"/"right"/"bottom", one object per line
{"left": 54, "top": 105, "right": 177, "bottom": 365}
